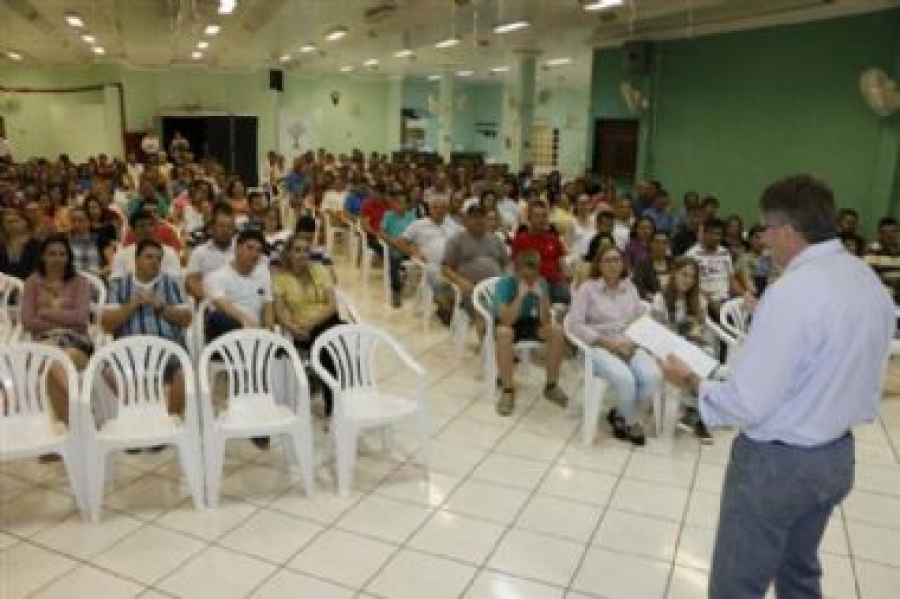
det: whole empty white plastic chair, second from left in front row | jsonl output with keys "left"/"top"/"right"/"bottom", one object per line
{"left": 81, "top": 335, "right": 203, "bottom": 521}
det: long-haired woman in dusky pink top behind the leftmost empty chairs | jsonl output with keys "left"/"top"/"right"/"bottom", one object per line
{"left": 22, "top": 234, "right": 93, "bottom": 422}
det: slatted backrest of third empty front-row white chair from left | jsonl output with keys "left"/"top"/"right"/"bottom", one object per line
{"left": 197, "top": 329, "right": 309, "bottom": 418}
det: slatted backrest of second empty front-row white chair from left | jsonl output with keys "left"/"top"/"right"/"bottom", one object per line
{"left": 82, "top": 335, "right": 197, "bottom": 432}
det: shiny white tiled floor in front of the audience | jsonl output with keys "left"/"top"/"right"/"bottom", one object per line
{"left": 0, "top": 262, "right": 900, "bottom": 599}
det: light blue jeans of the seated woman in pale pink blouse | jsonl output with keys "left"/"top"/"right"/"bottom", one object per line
{"left": 594, "top": 348, "right": 662, "bottom": 424}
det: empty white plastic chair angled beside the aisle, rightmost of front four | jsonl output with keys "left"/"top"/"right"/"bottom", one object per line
{"left": 311, "top": 324, "right": 430, "bottom": 495}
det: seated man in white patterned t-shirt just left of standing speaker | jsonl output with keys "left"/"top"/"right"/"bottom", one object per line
{"left": 686, "top": 218, "right": 743, "bottom": 318}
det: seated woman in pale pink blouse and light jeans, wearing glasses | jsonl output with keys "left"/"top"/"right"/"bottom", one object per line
{"left": 568, "top": 246, "right": 662, "bottom": 445}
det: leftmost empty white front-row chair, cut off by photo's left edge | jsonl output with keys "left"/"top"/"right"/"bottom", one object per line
{"left": 0, "top": 343, "right": 88, "bottom": 517}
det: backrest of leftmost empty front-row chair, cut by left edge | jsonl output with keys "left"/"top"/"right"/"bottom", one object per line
{"left": 0, "top": 343, "right": 78, "bottom": 426}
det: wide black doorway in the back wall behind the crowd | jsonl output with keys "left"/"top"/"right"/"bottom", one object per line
{"left": 162, "top": 114, "right": 259, "bottom": 187}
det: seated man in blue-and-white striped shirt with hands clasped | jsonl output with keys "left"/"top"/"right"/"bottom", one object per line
{"left": 101, "top": 239, "right": 192, "bottom": 414}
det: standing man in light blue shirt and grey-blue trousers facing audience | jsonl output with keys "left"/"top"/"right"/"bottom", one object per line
{"left": 664, "top": 175, "right": 895, "bottom": 599}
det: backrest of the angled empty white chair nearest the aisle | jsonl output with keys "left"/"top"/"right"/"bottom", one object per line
{"left": 310, "top": 324, "right": 402, "bottom": 392}
